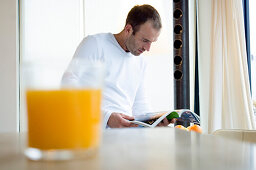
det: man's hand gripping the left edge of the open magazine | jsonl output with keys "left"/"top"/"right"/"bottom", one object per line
{"left": 108, "top": 113, "right": 138, "bottom": 128}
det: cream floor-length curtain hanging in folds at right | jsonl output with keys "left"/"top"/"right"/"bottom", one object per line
{"left": 198, "top": 0, "right": 255, "bottom": 133}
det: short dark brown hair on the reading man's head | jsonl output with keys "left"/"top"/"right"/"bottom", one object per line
{"left": 125, "top": 4, "right": 162, "bottom": 34}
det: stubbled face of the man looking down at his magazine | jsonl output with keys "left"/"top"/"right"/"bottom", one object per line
{"left": 125, "top": 21, "right": 160, "bottom": 56}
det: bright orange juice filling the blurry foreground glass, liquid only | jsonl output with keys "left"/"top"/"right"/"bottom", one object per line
{"left": 26, "top": 89, "right": 101, "bottom": 150}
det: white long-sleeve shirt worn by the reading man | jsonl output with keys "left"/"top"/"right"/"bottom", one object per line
{"left": 62, "top": 33, "right": 151, "bottom": 127}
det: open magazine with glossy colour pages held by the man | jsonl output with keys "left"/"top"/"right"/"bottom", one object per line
{"left": 131, "top": 109, "right": 200, "bottom": 128}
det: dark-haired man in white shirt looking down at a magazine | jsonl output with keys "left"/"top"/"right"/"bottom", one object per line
{"left": 62, "top": 5, "right": 167, "bottom": 128}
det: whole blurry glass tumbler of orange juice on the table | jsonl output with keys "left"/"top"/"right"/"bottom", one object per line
{"left": 23, "top": 60, "right": 104, "bottom": 160}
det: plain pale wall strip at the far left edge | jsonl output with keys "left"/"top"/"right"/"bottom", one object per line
{"left": 0, "top": 0, "right": 19, "bottom": 132}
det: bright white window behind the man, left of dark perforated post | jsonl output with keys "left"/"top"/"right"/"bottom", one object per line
{"left": 20, "top": 0, "right": 173, "bottom": 130}
